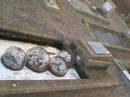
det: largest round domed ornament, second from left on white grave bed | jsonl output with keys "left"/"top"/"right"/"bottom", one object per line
{"left": 26, "top": 47, "right": 50, "bottom": 72}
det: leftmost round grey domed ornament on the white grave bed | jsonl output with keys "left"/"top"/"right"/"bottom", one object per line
{"left": 1, "top": 46, "right": 26, "bottom": 70}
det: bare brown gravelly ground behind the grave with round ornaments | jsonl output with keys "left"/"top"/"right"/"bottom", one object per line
{"left": 0, "top": 0, "right": 128, "bottom": 39}
